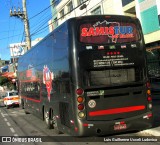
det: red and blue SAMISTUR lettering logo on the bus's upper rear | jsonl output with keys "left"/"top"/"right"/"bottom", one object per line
{"left": 81, "top": 20, "right": 134, "bottom": 43}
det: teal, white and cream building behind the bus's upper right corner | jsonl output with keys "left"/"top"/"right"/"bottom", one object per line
{"left": 122, "top": 0, "right": 160, "bottom": 49}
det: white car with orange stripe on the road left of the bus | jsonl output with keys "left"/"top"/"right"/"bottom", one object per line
{"left": 4, "top": 91, "right": 20, "bottom": 109}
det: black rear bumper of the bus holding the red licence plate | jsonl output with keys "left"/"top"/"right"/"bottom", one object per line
{"left": 76, "top": 112, "right": 153, "bottom": 136}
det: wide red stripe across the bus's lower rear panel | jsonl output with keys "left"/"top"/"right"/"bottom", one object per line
{"left": 89, "top": 105, "right": 145, "bottom": 116}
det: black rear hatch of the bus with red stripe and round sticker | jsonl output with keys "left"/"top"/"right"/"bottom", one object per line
{"left": 85, "top": 85, "right": 147, "bottom": 121}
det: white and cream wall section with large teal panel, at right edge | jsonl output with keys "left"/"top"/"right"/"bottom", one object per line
{"left": 136, "top": 0, "right": 160, "bottom": 43}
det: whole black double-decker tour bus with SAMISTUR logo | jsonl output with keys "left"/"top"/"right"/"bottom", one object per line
{"left": 18, "top": 15, "right": 152, "bottom": 136}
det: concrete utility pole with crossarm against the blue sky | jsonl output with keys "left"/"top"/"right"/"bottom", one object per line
{"left": 10, "top": 0, "right": 31, "bottom": 50}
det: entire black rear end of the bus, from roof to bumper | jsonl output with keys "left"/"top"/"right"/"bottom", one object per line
{"left": 72, "top": 16, "right": 152, "bottom": 135}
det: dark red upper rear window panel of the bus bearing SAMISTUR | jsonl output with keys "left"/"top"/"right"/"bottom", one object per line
{"left": 79, "top": 20, "right": 140, "bottom": 44}
